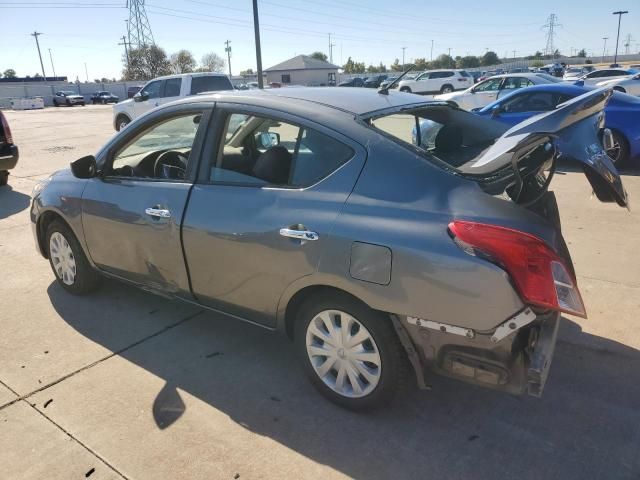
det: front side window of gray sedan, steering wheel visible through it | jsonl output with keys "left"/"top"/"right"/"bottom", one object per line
{"left": 107, "top": 113, "right": 202, "bottom": 180}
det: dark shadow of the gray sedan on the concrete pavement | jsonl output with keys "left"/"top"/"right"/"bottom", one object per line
{"left": 48, "top": 281, "right": 640, "bottom": 480}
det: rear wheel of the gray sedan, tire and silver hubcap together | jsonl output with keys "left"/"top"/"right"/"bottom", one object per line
{"left": 295, "top": 293, "right": 408, "bottom": 410}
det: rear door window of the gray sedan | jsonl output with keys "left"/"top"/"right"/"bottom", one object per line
{"left": 208, "top": 113, "right": 354, "bottom": 187}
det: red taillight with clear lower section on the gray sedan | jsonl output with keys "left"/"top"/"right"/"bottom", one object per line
{"left": 449, "top": 220, "right": 586, "bottom": 317}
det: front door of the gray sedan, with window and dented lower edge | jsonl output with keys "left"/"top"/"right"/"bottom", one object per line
{"left": 82, "top": 105, "right": 210, "bottom": 298}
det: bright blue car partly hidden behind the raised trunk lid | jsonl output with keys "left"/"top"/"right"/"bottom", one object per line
{"left": 474, "top": 83, "right": 640, "bottom": 167}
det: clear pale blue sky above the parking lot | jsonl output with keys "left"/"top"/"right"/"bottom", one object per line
{"left": 0, "top": 0, "right": 640, "bottom": 80}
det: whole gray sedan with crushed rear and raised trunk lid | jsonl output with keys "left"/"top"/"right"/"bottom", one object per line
{"left": 31, "top": 88, "right": 627, "bottom": 409}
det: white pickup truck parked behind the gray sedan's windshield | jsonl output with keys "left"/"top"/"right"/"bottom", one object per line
{"left": 113, "top": 72, "right": 233, "bottom": 131}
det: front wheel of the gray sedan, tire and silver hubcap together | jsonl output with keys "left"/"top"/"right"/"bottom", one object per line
{"left": 46, "top": 220, "right": 101, "bottom": 295}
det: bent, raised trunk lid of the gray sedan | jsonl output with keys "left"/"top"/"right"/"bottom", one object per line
{"left": 458, "top": 89, "right": 629, "bottom": 208}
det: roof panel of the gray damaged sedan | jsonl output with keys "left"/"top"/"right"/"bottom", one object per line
{"left": 191, "top": 87, "right": 436, "bottom": 115}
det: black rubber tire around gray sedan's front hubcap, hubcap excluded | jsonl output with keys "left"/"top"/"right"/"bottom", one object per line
{"left": 45, "top": 220, "right": 102, "bottom": 295}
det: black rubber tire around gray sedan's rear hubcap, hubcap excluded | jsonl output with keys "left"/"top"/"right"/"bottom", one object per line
{"left": 294, "top": 292, "right": 409, "bottom": 411}
